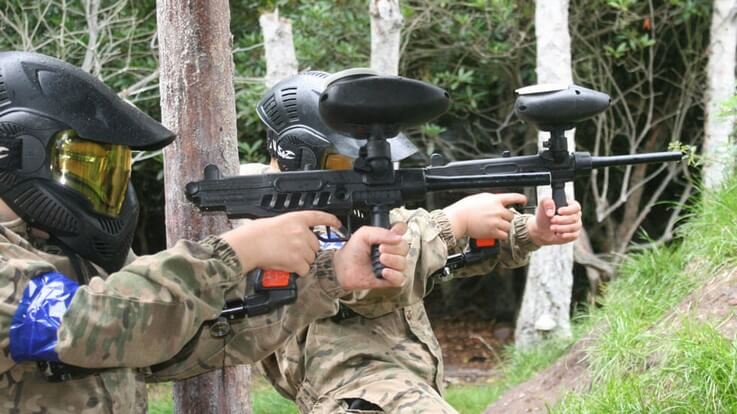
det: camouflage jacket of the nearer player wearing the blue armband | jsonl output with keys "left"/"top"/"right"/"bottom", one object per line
{"left": 0, "top": 220, "right": 345, "bottom": 414}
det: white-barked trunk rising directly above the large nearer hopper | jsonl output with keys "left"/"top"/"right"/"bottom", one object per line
{"left": 369, "top": 0, "right": 404, "bottom": 75}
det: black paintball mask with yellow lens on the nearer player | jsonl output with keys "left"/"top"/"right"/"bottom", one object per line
{"left": 0, "top": 52, "right": 175, "bottom": 272}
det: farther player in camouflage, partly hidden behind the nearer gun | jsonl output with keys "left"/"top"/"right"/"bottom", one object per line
{"left": 241, "top": 71, "right": 581, "bottom": 414}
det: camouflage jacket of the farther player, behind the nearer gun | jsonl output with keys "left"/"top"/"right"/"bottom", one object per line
{"left": 259, "top": 209, "right": 537, "bottom": 413}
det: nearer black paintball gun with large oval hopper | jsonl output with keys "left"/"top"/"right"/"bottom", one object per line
{"left": 186, "top": 74, "right": 551, "bottom": 277}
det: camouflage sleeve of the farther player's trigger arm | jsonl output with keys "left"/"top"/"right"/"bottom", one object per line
{"left": 341, "top": 208, "right": 455, "bottom": 318}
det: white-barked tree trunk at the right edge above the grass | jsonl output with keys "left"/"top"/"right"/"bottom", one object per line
{"left": 703, "top": 0, "right": 737, "bottom": 188}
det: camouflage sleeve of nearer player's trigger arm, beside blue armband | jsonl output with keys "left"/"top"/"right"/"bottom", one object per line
{"left": 56, "top": 237, "right": 243, "bottom": 368}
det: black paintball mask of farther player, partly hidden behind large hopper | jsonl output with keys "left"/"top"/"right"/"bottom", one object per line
{"left": 256, "top": 71, "right": 417, "bottom": 171}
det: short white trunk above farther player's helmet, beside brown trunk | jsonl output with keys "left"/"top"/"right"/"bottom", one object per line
{"left": 258, "top": 9, "right": 299, "bottom": 88}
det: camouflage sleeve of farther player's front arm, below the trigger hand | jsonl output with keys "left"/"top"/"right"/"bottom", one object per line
{"left": 452, "top": 211, "right": 540, "bottom": 278}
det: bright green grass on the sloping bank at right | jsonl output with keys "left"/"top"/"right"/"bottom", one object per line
{"left": 551, "top": 181, "right": 737, "bottom": 413}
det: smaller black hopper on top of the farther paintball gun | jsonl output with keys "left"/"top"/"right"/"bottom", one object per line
{"left": 514, "top": 84, "right": 612, "bottom": 131}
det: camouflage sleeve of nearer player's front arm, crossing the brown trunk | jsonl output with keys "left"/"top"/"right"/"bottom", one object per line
{"left": 146, "top": 250, "right": 346, "bottom": 382}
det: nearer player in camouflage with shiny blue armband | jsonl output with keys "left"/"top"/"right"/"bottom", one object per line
{"left": 0, "top": 52, "right": 408, "bottom": 413}
